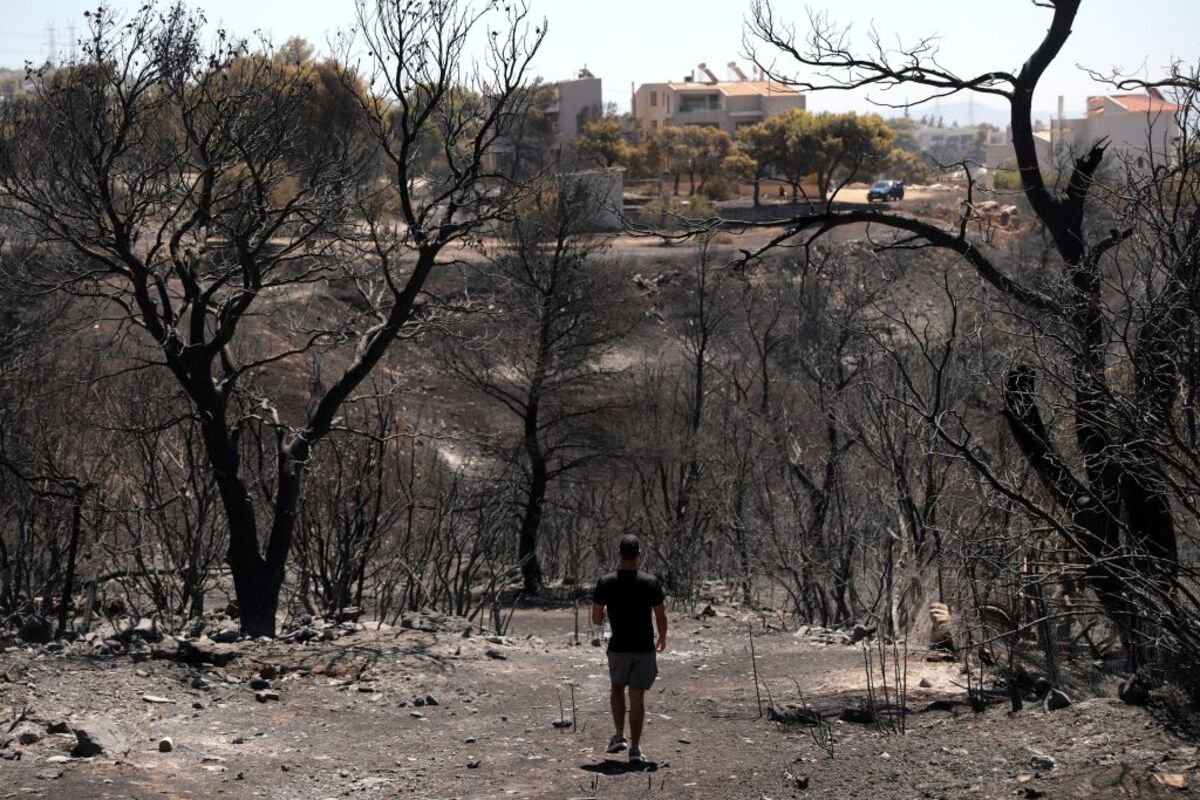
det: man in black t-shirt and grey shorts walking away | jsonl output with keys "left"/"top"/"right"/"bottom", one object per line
{"left": 592, "top": 534, "right": 667, "bottom": 764}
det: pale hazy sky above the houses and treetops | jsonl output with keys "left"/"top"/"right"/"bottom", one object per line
{"left": 0, "top": 0, "right": 1200, "bottom": 120}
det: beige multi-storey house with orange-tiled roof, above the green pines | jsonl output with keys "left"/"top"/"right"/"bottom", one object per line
{"left": 632, "top": 64, "right": 805, "bottom": 136}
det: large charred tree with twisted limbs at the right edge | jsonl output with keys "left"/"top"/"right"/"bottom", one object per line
{"left": 750, "top": 0, "right": 1200, "bottom": 662}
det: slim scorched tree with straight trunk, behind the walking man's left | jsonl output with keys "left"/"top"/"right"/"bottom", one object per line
{"left": 445, "top": 175, "right": 620, "bottom": 594}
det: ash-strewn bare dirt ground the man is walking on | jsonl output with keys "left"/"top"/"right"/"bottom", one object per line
{"left": 0, "top": 612, "right": 1200, "bottom": 800}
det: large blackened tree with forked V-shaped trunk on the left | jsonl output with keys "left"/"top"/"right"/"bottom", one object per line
{"left": 0, "top": 0, "right": 544, "bottom": 636}
